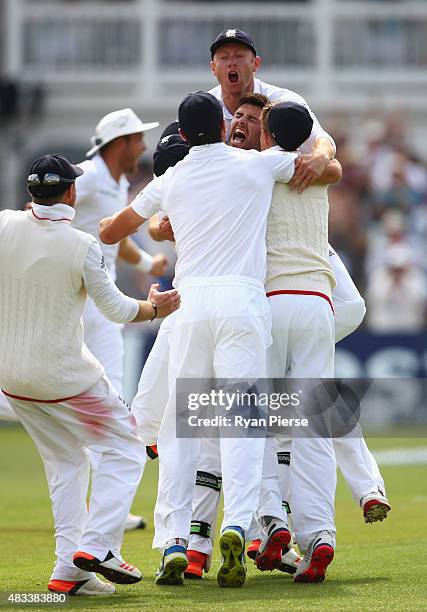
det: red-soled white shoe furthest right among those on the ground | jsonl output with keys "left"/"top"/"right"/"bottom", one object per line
{"left": 294, "top": 531, "right": 334, "bottom": 582}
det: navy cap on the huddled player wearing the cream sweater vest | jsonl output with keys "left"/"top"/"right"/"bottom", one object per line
{"left": 268, "top": 102, "right": 313, "bottom": 151}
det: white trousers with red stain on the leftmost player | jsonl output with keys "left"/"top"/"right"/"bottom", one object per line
{"left": 8, "top": 377, "right": 145, "bottom": 580}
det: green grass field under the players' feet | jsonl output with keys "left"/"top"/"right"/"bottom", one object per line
{"left": 0, "top": 427, "right": 427, "bottom": 611}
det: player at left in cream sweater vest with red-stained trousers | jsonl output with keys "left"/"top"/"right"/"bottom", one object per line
{"left": 0, "top": 155, "right": 179, "bottom": 595}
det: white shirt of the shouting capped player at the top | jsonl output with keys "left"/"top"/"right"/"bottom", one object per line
{"left": 209, "top": 79, "right": 335, "bottom": 153}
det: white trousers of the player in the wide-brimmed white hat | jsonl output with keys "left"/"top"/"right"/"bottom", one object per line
{"left": 83, "top": 297, "right": 124, "bottom": 397}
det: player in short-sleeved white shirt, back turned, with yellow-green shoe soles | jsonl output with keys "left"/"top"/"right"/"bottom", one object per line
{"left": 100, "top": 92, "right": 297, "bottom": 586}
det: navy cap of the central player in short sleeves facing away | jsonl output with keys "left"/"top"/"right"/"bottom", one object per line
{"left": 178, "top": 91, "right": 223, "bottom": 145}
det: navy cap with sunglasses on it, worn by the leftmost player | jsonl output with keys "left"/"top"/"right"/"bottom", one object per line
{"left": 27, "top": 155, "right": 83, "bottom": 198}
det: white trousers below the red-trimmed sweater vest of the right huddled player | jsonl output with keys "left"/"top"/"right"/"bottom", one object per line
{"left": 270, "top": 294, "right": 336, "bottom": 551}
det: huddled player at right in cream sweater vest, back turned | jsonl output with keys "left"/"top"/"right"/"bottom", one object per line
{"left": 257, "top": 102, "right": 339, "bottom": 582}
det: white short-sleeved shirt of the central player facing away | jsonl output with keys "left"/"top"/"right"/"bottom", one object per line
{"left": 131, "top": 143, "right": 297, "bottom": 287}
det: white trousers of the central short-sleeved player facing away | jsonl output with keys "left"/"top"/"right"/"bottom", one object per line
{"left": 153, "top": 277, "right": 271, "bottom": 548}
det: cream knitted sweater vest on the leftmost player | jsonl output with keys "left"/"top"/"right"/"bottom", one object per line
{"left": 0, "top": 210, "right": 104, "bottom": 401}
